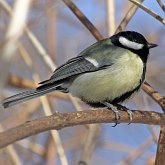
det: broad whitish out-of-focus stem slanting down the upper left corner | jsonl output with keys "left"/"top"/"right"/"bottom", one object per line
{"left": 0, "top": 0, "right": 31, "bottom": 91}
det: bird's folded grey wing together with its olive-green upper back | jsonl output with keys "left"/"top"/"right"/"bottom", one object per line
{"left": 40, "top": 39, "right": 115, "bottom": 85}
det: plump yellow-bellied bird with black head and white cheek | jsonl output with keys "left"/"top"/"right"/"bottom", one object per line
{"left": 2, "top": 31, "right": 157, "bottom": 124}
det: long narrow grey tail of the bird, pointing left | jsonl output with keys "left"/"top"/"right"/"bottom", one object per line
{"left": 2, "top": 84, "right": 59, "bottom": 108}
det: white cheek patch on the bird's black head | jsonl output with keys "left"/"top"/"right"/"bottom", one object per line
{"left": 119, "top": 37, "right": 144, "bottom": 50}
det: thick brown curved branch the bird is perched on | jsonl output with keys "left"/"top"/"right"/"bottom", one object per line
{"left": 0, "top": 108, "right": 165, "bottom": 148}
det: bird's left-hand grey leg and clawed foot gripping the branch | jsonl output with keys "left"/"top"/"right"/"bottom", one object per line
{"left": 102, "top": 102, "right": 120, "bottom": 127}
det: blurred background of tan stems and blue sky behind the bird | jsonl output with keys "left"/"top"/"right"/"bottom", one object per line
{"left": 0, "top": 0, "right": 165, "bottom": 165}
